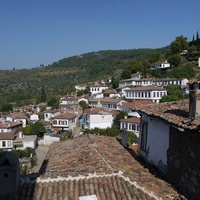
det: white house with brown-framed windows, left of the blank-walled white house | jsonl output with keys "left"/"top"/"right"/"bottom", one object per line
{"left": 51, "top": 113, "right": 77, "bottom": 130}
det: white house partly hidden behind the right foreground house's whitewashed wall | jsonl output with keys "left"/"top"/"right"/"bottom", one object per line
{"left": 120, "top": 117, "right": 140, "bottom": 137}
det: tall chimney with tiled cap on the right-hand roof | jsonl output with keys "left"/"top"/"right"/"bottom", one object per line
{"left": 188, "top": 78, "right": 200, "bottom": 119}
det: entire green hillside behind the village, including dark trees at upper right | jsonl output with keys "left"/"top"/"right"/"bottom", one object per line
{"left": 0, "top": 32, "right": 200, "bottom": 106}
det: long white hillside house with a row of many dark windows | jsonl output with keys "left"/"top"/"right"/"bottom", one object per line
{"left": 123, "top": 86, "right": 167, "bottom": 103}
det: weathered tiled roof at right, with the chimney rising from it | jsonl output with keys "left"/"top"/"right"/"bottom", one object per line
{"left": 136, "top": 100, "right": 200, "bottom": 129}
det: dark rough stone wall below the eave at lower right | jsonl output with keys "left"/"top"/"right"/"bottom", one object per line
{"left": 167, "top": 127, "right": 200, "bottom": 200}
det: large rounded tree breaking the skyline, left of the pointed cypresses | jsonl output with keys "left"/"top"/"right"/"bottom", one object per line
{"left": 170, "top": 35, "right": 188, "bottom": 55}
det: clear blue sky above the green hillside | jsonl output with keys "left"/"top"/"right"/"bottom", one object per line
{"left": 0, "top": 0, "right": 200, "bottom": 69}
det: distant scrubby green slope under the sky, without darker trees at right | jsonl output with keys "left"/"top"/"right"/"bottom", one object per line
{"left": 0, "top": 47, "right": 169, "bottom": 104}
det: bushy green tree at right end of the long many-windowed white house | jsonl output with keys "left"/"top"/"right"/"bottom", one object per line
{"left": 160, "top": 85, "right": 183, "bottom": 103}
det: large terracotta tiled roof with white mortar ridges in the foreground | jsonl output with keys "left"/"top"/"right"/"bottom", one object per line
{"left": 19, "top": 135, "right": 179, "bottom": 200}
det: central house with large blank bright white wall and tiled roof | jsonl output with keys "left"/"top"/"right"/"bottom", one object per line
{"left": 83, "top": 108, "right": 113, "bottom": 129}
